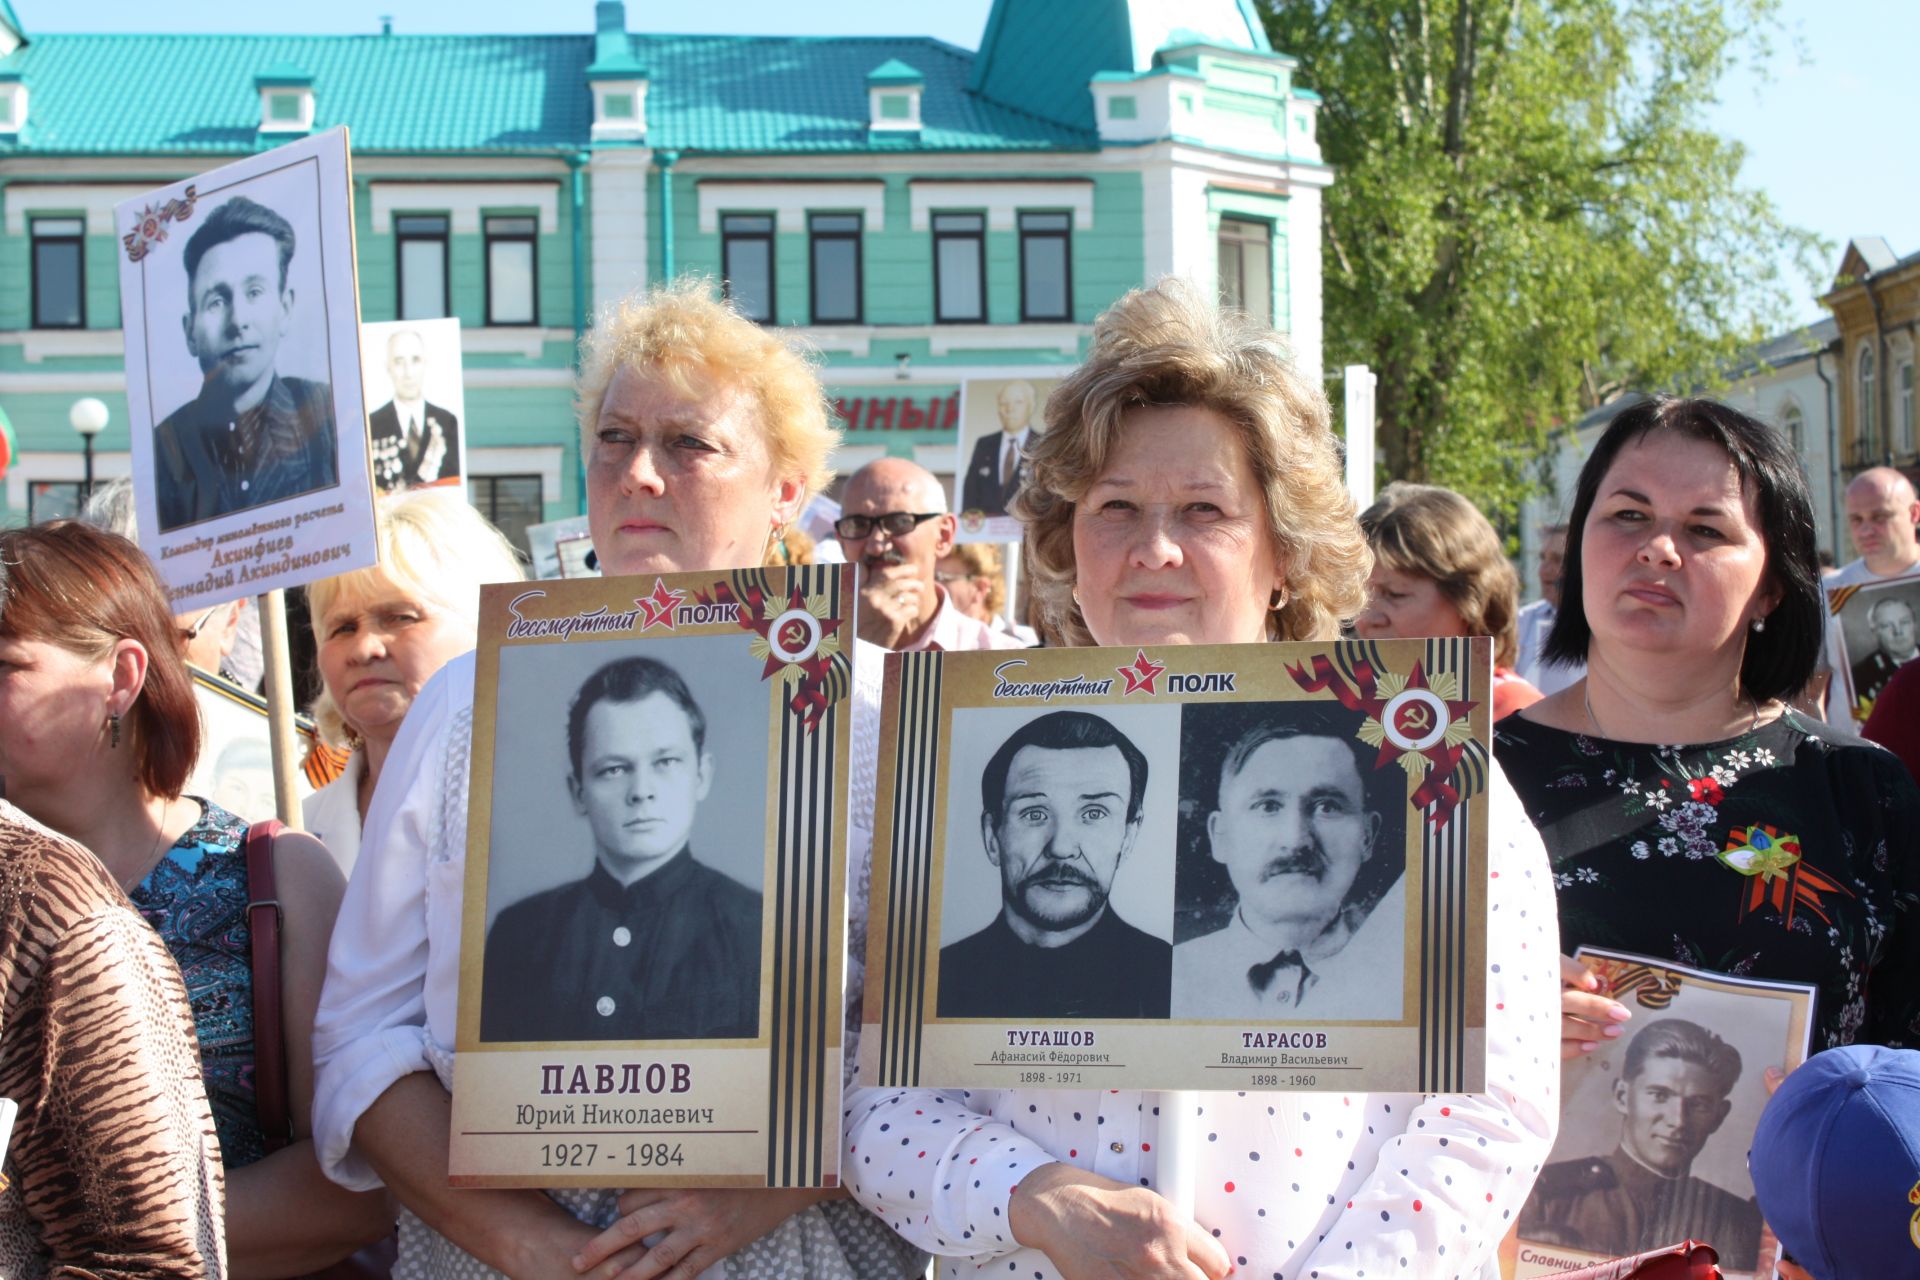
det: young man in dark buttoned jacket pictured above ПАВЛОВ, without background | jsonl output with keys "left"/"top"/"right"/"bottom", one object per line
{"left": 480, "top": 658, "right": 760, "bottom": 1042}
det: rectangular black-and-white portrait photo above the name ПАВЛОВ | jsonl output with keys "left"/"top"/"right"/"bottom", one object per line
{"left": 480, "top": 637, "right": 768, "bottom": 1044}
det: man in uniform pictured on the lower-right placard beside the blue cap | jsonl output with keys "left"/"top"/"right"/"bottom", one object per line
{"left": 1521, "top": 1017, "right": 1761, "bottom": 1270}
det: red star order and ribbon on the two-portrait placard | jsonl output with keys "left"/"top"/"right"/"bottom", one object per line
{"left": 1286, "top": 654, "right": 1478, "bottom": 827}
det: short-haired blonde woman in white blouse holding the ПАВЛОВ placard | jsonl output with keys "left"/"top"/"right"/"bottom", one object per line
{"left": 313, "top": 282, "right": 924, "bottom": 1280}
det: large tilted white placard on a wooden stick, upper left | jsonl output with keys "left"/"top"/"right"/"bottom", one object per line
{"left": 115, "top": 129, "right": 378, "bottom": 612}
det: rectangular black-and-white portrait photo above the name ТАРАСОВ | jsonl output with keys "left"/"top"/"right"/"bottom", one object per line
{"left": 1173, "top": 702, "right": 1407, "bottom": 1021}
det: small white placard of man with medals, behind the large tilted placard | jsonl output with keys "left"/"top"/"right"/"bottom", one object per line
{"left": 361, "top": 319, "right": 467, "bottom": 493}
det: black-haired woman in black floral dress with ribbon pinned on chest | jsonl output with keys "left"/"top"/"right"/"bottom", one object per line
{"left": 1494, "top": 399, "right": 1920, "bottom": 1057}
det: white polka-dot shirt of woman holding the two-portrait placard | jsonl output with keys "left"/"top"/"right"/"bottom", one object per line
{"left": 841, "top": 766, "right": 1561, "bottom": 1280}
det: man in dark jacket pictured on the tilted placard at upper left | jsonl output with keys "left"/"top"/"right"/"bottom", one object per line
{"left": 154, "top": 196, "right": 338, "bottom": 532}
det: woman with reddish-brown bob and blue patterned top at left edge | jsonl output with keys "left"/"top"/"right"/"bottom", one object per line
{"left": 0, "top": 520, "right": 392, "bottom": 1276}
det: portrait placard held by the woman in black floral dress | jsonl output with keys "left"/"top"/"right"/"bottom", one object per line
{"left": 1513, "top": 946, "right": 1814, "bottom": 1280}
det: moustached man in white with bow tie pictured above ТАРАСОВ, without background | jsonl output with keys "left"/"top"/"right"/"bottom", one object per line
{"left": 1173, "top": 704, "right": 1405, "bottom": 1021}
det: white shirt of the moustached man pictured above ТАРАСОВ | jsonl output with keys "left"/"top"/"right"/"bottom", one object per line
{"left": 1173, "top": 875, "right": 1407, "bottom": 1021}
